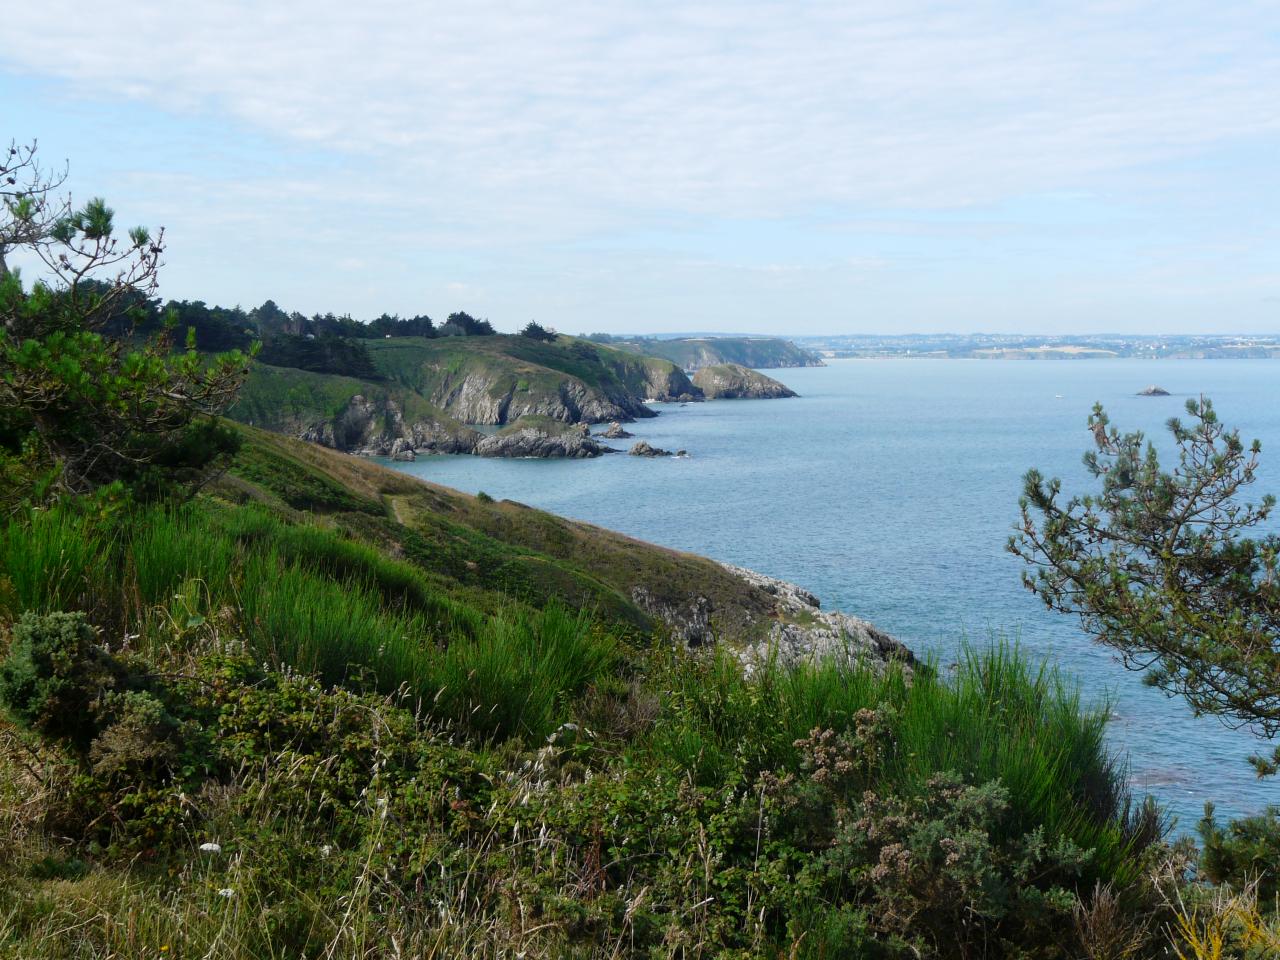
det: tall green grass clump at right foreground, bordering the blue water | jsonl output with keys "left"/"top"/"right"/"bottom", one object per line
{"left": 650, "top": 643, "right": 1158, "bottom": 881}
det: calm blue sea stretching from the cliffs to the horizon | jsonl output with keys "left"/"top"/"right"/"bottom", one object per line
{"left": 396, "top": 360, "right": 1280, "bottom": 831}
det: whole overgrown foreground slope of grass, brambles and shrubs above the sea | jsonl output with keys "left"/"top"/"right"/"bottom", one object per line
{"left": 0, "top": 429, "right": 1167, "bottom": 960}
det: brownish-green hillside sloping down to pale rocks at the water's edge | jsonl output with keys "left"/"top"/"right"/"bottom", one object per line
{"left": 215, "top": 430, "right": 772, "bottom": 640}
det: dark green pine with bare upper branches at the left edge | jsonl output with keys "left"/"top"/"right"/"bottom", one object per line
{"left": 0, "top": 145, "right": 248, "bottom": 498}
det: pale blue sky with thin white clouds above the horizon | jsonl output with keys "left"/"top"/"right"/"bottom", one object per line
{"left": 0, "top": 0, "right": 1280, "bottom": 335}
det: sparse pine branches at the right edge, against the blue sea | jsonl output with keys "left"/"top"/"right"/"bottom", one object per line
{"left": 1009, "top": 399, "right": 1280, "bottom": 776}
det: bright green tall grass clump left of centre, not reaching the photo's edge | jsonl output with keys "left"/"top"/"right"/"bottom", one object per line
{"left": 237, "top": 548, "right": 617, "bottom": 741}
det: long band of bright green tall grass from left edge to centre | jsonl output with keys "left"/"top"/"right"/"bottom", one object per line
{"left": 0, "top": 503, "right": 617, "bottom": 741}
